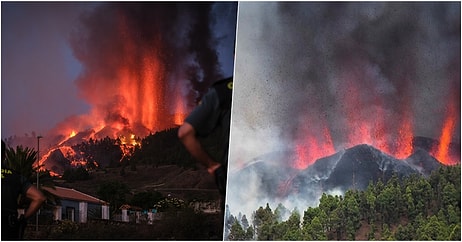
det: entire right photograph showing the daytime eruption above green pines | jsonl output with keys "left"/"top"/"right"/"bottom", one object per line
{"left": 224, "top": 2, "right": 461, "bottom": 240}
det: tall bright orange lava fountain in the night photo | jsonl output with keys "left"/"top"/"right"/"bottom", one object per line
{"left": 116, "top": 12, "right": 166, "bottom": 134}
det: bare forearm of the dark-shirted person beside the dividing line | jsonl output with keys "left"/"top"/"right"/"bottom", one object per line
{"left": 178, "top": 122, "right": 221, "bottom": 174}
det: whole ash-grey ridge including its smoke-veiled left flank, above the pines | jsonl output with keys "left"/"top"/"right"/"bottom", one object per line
{"left": 230, "top": 144, "right": 440, "bottom": 199}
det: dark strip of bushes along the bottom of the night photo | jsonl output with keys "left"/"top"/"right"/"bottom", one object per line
{"left": 24, "top": 209, "right": 223, "bottom": 240}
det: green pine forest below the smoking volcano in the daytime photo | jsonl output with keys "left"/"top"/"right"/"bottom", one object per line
{"left": 226, "top": 165, "right": 461, "bottom": 241}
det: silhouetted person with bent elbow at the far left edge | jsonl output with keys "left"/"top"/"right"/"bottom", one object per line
{"left": 1, "top": 140, "right": 46, "bottom": 240}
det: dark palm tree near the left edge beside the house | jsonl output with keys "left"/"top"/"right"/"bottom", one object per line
{"left": 5, "top": 146, "right": 57, "bottom": 206}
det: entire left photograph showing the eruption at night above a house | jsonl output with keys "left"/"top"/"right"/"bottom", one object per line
{"left": 1, "top": 2, "right": 238, "bottom": 240}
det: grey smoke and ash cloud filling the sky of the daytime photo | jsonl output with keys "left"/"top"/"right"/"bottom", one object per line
{"left": 227, "top": 2, "right": 461, "bottom": 215}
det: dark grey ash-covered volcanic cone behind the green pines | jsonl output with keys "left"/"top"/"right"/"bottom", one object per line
{"left": 296, "top": 144, "right": 439, "bottom": 192}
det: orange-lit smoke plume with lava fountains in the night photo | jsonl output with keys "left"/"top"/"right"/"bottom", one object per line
{"left": 46, "top": 2, "right": 237, "bottom": 140}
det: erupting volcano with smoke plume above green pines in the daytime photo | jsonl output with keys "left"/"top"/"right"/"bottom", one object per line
{"left": 227, "top": 3, "right": 461, "bottom": 218}
